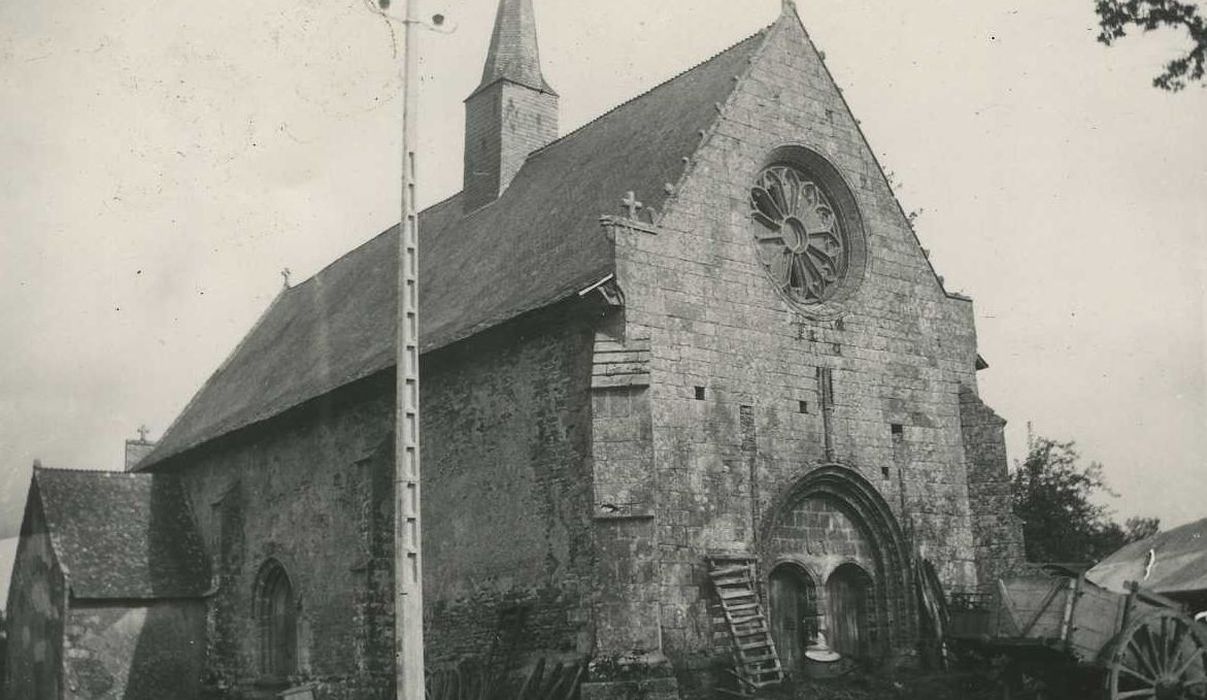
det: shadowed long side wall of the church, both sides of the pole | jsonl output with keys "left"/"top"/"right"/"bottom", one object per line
{"left": 158, "top": 301, "right": 594, "bottom": 699}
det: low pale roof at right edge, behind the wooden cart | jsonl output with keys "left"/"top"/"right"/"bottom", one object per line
{"left": 1085, "top": 518, "right": 1207, "bottom": 594}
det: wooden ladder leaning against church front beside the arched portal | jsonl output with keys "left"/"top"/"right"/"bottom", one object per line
{"left": 709, "top": 560, "right": 783, "bottom": 695}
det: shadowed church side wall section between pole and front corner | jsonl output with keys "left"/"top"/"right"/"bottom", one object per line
{"left": 420, "top": 299, "right": 596, "bottom": 663}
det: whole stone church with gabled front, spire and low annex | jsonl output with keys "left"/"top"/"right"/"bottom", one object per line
{"left": 6, "top": 0, "right": 1021, "bottom": 699}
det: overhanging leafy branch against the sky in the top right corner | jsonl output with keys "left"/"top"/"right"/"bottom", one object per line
{"left": 1095, "top": 0, "right": 1207, "bottom": 92}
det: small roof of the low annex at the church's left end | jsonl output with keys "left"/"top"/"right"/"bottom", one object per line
{"left": 34, "top": 468, "right": 210, "bottom": 600}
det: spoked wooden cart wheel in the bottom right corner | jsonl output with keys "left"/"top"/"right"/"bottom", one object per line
{"left": 1106, "top": 609, "right": 1207, "bottom": 700}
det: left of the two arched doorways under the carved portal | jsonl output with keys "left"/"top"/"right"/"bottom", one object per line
{"left": 768, "top": 564, "right": 818, "bottom": 672}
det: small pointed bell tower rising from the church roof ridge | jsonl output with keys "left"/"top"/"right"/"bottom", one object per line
{"left": 462, "top": 0, "right": 558, "bottom": 211}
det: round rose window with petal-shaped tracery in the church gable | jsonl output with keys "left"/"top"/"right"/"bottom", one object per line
{"left": 751, "top": 165, "right": 850, "bottom": 304}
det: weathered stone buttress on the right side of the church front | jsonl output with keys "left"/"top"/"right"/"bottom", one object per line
{"left": 960, "top": 387, "right": 1026, "bottom": 591}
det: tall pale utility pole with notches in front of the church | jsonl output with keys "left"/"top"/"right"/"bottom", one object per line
{"left": 393, "top": 0, "right": 424, "bottom": 700}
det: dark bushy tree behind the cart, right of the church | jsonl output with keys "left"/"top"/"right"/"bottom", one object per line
{"left": 1011, "top": 437, "right": 1160, "bottom": 562}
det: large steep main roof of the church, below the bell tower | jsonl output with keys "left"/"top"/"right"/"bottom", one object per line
{"left": 139, "top": 29, "right": 766, "bottom": 469}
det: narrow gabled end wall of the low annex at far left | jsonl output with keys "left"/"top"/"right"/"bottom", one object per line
{"left": 0, "top": 488, "right": 66, "bottom": 699}
